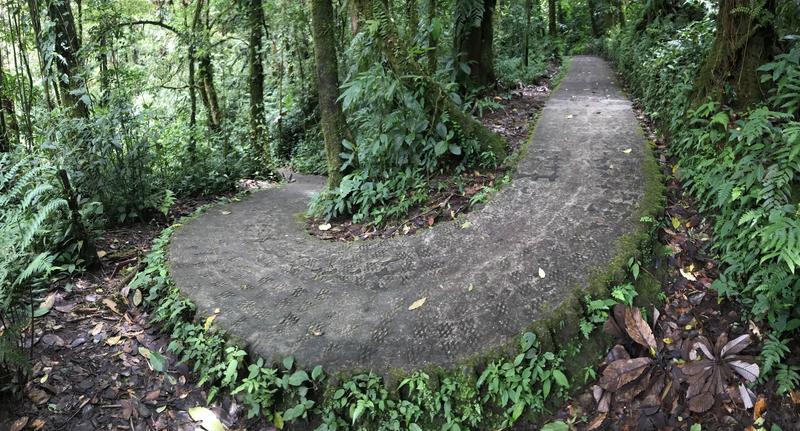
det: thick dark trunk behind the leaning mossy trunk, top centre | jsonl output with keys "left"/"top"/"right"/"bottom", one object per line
{"left": 453, "top": 0, "right": 497, "bottom": 89}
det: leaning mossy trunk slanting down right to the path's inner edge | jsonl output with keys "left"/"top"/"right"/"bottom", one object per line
{"left": 355, "top": 0, "right": 507, "bottom": 160}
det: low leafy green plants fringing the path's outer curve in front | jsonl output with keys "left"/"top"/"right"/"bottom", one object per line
{"left": 122, "top": 201, "right": 649, "bottom": 431}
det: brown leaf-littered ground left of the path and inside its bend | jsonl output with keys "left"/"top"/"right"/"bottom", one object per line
{"left": 0, "top": 71, "right": 555, "bottom": 431}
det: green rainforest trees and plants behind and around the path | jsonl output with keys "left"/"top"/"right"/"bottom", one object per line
{"left": 0, "top": 0, "right": 800, "bottom": 429}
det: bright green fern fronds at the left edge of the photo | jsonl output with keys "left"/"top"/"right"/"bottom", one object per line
{"left": 0, "top": 154, "right": 95, "bottom": 391}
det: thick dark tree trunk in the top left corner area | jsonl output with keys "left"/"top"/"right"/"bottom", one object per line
{"left": 47, "top": 0, "right": 89, "bottom": 118}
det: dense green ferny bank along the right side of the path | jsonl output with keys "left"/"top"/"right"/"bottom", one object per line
{"left": 605, "top": 2, "right": 800, "bottom": 393}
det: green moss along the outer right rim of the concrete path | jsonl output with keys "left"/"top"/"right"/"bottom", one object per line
{"left": 145, "top": 59, "right": 664, "bottom": 426}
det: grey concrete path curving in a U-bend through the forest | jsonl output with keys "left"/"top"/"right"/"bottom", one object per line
{"left": 170, "top": 56, "right": 644, "bottom": 371}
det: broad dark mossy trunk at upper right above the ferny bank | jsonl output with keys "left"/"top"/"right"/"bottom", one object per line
{"left": 693, "top": 0, "right": 777, "bottom": 109}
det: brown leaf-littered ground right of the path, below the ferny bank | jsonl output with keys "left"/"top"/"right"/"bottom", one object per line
{"left": 553, "top": 102, "right": 800, "bottom": 431}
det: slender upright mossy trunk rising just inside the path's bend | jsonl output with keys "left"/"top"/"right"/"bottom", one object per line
{"left": 311, "top": 0, "right": 350, "bottom": 188}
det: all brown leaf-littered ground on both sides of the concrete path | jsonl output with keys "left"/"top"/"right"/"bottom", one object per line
{"left": 0, "top": 61, "right": 800, "bottom": 431}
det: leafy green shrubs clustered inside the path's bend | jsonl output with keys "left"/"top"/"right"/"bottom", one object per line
{"left": 309, "top": 21, "right": 496, "bottom": 224}
